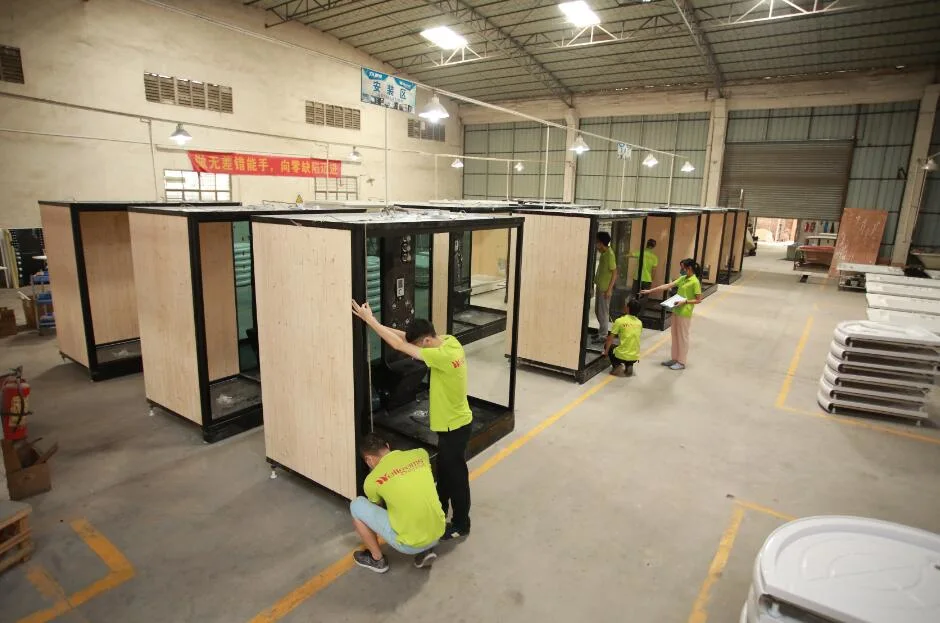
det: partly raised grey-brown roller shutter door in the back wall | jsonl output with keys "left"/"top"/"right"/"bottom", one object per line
{"left": 720, "top": 141, "right": 854, "bottom": 220}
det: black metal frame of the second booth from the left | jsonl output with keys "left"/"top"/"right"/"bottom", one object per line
{"left": 129, "top": 203, "right": 365, "bottom": 443}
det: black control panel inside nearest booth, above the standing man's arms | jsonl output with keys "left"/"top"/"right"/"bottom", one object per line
{"left": 382, "top": 235, "right": 415, "bottom": 338}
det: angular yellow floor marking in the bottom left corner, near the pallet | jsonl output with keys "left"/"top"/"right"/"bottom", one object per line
{"left": 17, "top": 519, "right": 135, "bottom": 623}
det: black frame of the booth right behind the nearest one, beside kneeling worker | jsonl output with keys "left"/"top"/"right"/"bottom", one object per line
{"left": 513, "top": 206, "right": 646, "bottom": 383}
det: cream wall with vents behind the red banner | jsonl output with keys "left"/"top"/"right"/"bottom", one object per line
{"left": 0, "top": 0, "right": 463, "bottom": 227}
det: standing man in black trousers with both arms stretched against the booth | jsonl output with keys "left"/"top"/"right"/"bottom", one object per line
{"left": 352, "top": 301, "right": 473, "bottom": 541}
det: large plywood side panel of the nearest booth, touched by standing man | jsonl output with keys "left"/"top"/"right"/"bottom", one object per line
{"left": 253, "top": 223, "right": 356, "bottom": 498}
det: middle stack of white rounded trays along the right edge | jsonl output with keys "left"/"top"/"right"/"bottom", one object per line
{"left": 817, "top": 320, "right": 940, "bottom": 421}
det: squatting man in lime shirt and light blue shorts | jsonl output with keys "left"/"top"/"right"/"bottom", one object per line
{"left": 349, "top": 433, "right": 445, "bottom": 573}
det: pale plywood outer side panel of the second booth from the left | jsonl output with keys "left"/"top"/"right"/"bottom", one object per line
{"left": 128, "top": 212, "right": 202, "bottom": 425}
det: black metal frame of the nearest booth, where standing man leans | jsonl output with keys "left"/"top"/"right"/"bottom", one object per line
{"left": 251, "top": 215, "right": 524, "bottom": 494}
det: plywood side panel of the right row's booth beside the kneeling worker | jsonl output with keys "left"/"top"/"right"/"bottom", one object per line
{"left": 518, "top": 214, "right": 593, "bottom": 369}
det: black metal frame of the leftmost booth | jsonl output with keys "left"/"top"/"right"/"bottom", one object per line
{"left": 39, "top": 201, "right": 241, "bottom": 381}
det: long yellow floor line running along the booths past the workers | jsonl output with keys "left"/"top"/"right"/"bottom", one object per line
{"left": 249, "top": 275, "right": 756, "bottom": 623}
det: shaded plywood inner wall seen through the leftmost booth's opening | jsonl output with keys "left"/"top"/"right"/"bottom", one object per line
{"left": 79, "top": 210, "right": 140, "bottom": 344}
